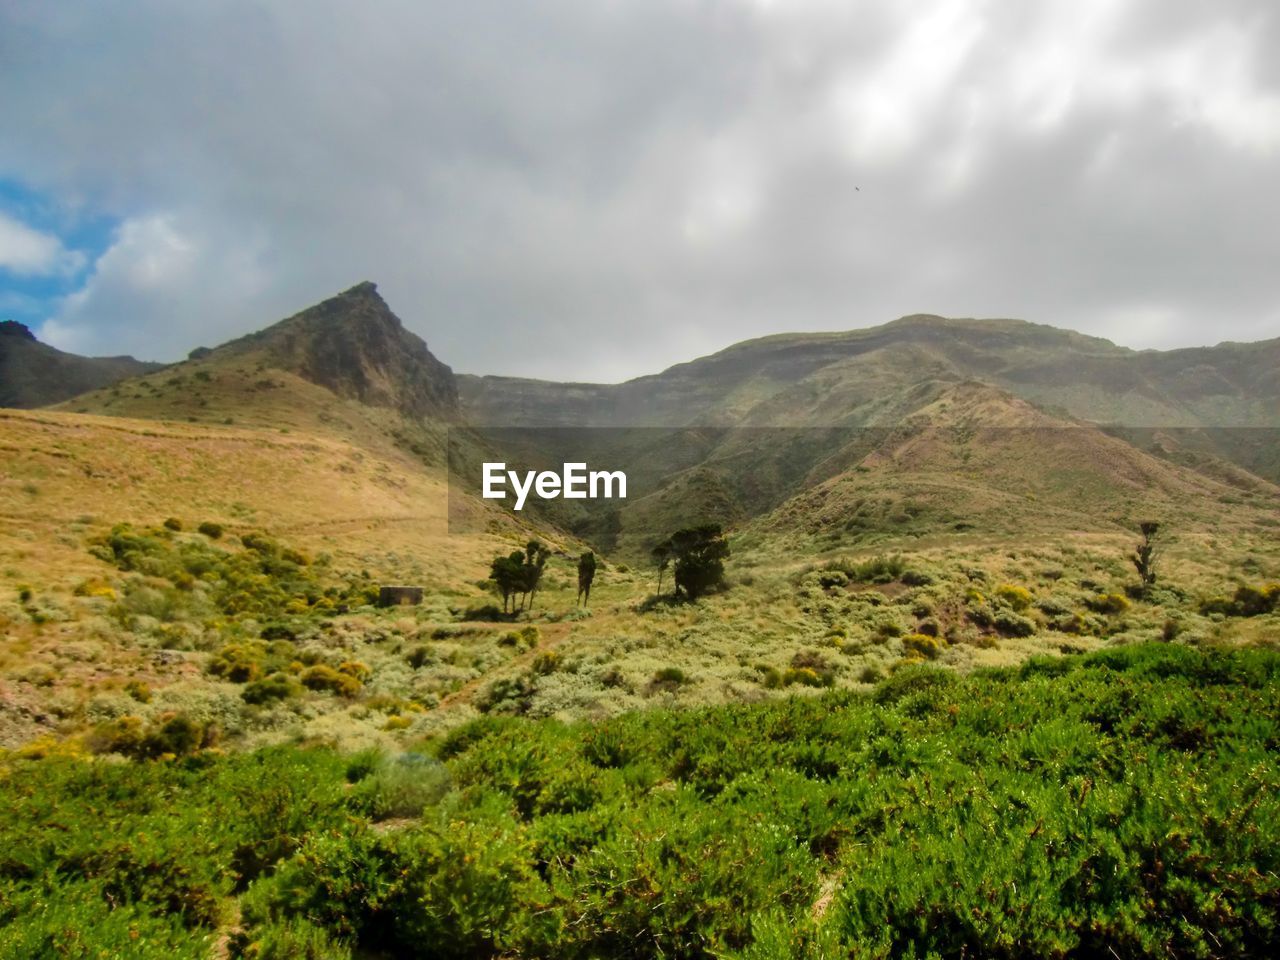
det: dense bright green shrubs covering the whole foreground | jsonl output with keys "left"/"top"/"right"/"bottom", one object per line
{"left": 0, "top": 644, "right": 1280, "bottom": 960}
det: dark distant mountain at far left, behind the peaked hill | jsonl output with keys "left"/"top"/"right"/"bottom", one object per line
{"left": 0, "top": 320, "right": 164, "bottom": 407}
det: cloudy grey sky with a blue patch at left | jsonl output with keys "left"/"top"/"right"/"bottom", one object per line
{"left": 0, "top": 0, "right": 1280, "bottom": 381}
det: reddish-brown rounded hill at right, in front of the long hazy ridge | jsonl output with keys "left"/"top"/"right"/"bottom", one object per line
{"left": 763, "top": 381, "right": 1280, "bottom": 547}
